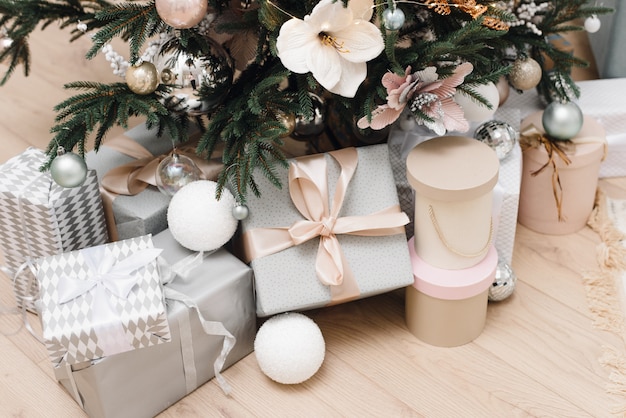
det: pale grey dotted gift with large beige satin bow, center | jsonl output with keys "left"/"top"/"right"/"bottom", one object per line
{"left": 241, "top": 145, "right": 413, "bottom": 316}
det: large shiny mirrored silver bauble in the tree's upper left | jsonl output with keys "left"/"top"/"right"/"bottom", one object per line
{"left": 154, "top": 38, "right": 234, "bottom": 116}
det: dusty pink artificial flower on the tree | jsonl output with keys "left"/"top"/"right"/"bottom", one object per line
{"left": 357, "top": 63, "right": 474, "bottom": 135}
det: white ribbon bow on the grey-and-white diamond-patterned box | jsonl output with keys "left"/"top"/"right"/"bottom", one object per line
{"left": 57, "top": 246, "right": 162, "bottom": 356}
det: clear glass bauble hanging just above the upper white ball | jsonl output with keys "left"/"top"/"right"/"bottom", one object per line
{"left": 156, "top": 152, "right": 202, "bottom": 196}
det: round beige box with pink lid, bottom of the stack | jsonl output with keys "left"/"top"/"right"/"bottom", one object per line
{"left": 405, "top": 239, "right": 498, "bottom": 347}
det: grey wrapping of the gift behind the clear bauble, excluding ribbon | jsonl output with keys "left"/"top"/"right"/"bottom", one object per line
{"left": 85, "top": 125, "right": 180, "bottom": 240}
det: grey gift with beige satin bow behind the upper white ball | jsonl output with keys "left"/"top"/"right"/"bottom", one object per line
{"left": 86, "top": 125, "right": 222, "bottom": 241}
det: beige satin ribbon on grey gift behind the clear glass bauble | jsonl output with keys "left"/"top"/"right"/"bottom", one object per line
{"left": 100, "top": 136, "right": 223, "bottom": 241}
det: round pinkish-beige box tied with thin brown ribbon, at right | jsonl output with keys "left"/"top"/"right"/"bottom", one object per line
{"left": 518, "top": 112, "right": 607, "bottom": 235}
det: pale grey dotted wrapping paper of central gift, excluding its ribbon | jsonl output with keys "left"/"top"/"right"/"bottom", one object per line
{"left": 241, "top": 145, "right": 413, "bottom": 316}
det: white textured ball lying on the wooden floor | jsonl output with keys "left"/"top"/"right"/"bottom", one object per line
{"left": 254, "top": 313, "right": 326, "bottom": 385}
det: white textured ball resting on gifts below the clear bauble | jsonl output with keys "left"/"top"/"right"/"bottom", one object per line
{"left": 167, "top": 180, "right": 238, "bottom": 251}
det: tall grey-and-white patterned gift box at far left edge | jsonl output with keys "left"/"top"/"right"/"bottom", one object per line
{"left": 0, "top": 148, "right": 108, "bottom": 312}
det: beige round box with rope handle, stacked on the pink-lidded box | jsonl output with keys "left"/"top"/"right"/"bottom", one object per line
{"left": 406, "top": 136, "right": 500, "bottom": 270}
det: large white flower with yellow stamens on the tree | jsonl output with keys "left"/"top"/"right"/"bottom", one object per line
{"left": 276, "top": 0, "right": 385, "bottom": 97}
